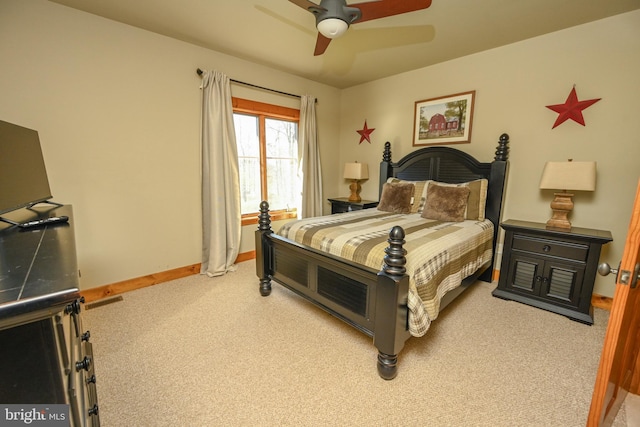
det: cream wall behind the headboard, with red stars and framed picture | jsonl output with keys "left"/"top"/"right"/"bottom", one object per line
{"left": 338, "top": 11, "right": 640, "bottom": 296}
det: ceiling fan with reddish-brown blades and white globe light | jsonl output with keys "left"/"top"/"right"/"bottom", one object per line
{"left": 289, "top": 0, "right": 432, "bottom": 56}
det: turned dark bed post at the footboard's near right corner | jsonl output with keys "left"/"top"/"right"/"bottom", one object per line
{"left": 373, "top": 226, "right": 409, "bottom": 380}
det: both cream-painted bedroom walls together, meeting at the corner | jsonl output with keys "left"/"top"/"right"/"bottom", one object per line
{"left": 0, "top": 0, "right": 640, "bottom": 296}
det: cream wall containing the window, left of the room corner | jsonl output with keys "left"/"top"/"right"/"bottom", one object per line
{"left": 0, "top": 0, "right": 339, "bottom": 288}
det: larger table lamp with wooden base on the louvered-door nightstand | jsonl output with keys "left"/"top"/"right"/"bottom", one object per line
{"left": 540, "top": 159, "right": 596, "bottom": 231}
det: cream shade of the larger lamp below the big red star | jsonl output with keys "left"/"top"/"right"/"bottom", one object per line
{"left": 540, "top": 161, "right": 596, "bottom": 191}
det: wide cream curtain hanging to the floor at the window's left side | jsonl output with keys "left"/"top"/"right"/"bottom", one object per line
{"left": 200, "top": 71, "right": 242, "bottom": 276}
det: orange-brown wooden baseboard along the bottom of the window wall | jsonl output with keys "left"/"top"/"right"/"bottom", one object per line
{"left": 80, "top": 251, "right": 256, "bottom": 303}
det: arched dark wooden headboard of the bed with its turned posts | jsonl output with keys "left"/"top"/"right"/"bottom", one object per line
{"left": 379, "top": 133, "right": 509, "bottom": 282}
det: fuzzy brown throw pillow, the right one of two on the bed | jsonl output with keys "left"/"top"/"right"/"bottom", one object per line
{"left": 421, "top": 183, "right": 471, "bottom": 222}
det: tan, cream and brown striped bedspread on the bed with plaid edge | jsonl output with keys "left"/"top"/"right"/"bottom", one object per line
{"left": 278, "top": 209, "right": 493, "bottom": 337}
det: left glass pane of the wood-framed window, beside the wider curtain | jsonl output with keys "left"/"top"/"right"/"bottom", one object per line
{"left": 233, "top": 114, "right": 262, "bottom": 214}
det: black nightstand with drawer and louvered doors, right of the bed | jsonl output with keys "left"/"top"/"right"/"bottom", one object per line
{"left": 493, "top": 220, "right": 613, "bottom": 325}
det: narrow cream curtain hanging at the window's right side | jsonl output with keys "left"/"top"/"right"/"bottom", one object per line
{"left": 298, "top": 95, "right": 322, "bottom": 218}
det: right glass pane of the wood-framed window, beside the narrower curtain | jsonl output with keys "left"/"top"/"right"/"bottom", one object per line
{"left": 265, "top": 118, "right": 302, "bottom": 210}
